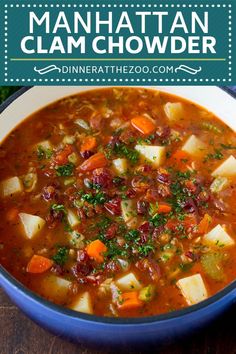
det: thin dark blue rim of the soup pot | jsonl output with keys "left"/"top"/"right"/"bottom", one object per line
{"left": 0, "top": 86, "right": 236, "bottom": 326}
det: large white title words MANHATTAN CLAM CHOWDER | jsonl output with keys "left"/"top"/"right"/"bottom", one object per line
{"left": 20, "top": 11, "right": 217, "bottom": 55}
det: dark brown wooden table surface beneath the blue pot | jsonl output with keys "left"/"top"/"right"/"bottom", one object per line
{"left": 0, "top": 289, "right": 236, "bottom": 354}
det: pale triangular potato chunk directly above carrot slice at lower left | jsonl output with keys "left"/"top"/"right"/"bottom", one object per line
{"left": 19, "top": 213, "right": 45, "bottom": 239}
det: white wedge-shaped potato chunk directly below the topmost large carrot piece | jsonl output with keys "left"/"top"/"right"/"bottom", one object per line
{"left": 135, "top": 145, "right": 166, "bottom": 167}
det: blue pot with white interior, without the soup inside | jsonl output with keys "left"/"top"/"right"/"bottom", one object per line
{"left": 0, "top": 86, "right": 236, "bottom": 348}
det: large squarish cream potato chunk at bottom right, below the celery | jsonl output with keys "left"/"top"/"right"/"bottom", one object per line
{"left": 176, "top": 274, "right": 208, "bottom": 305}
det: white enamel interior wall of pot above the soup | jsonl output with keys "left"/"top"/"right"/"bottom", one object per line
{"left": 0, "top": 86, "right": 236, "bottom": 141}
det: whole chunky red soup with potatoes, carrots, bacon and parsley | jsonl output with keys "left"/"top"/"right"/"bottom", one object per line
{"left": 0, "top": 88, "right": 236, "bottom": 317}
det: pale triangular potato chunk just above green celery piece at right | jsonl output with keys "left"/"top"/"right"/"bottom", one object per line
{"left": 203, "top": 225, "right": 235, "bottom": 247}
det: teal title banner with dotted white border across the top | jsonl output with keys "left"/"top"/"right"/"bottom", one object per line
{"left": 0, "top": 0, "right": 236, "bottom": 85}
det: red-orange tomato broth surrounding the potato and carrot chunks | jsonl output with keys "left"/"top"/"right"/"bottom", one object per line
{"left": 0, "top": 88, "right": 236, "bottom": 317}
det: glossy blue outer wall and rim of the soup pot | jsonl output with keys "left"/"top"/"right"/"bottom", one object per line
{"left": 0, "top": 88, "right": 236, "bottom": 350}
